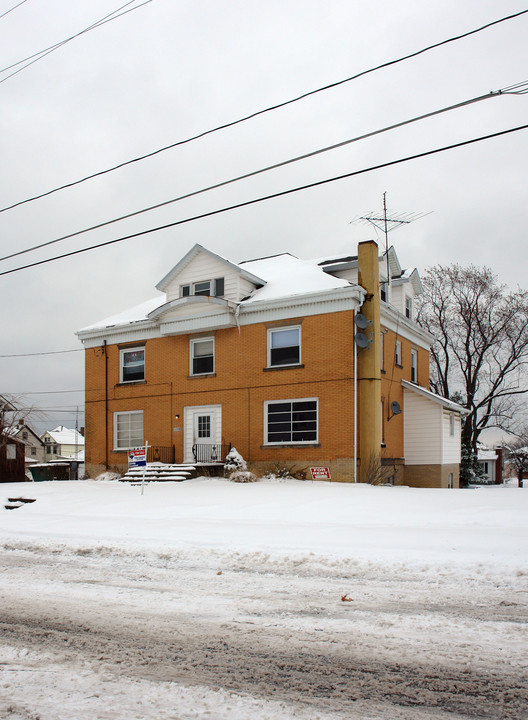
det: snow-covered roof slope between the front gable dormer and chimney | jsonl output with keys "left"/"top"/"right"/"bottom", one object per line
{"left": 241, "top": 253, "right": 350, "bottom": 303}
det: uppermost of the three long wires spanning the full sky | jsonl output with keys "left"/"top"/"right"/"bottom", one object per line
{"left": 0, "top": 7, "right": 528, "bottom": 213}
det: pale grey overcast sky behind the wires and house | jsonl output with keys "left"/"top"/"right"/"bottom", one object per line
{"left": 0, "top": 0, "right": 528, "bottom": 431}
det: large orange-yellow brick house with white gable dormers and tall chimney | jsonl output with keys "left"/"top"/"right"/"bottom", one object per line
{"left": 77, "top": 241, "right": 463, "bottom": 487}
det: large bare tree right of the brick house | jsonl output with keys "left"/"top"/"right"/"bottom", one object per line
{"left": 417, "top": 265, "right": 528, "bottom": 483}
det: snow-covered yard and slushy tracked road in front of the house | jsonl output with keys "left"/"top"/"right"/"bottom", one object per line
{"left": 0, "top": 478, "right": 528, "bottom": 720}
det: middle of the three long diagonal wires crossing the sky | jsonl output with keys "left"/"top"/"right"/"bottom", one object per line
{"left": 0, "top": 81, "right": 528, "bottom": 262}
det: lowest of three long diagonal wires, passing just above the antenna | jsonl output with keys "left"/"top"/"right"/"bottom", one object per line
{"left": 0, "top": 124, "right": 528, "bottom": 276}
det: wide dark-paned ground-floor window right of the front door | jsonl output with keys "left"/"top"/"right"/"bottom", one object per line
{"left": 264, "top": 398, "right": 318, "bottom": 445}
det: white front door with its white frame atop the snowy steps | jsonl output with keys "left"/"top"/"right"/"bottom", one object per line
{"left": 183, "top": 405, "right": 222, "bottom": 463}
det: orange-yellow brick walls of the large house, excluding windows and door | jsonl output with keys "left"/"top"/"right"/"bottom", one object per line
{"left": 86, "top": 311, "right": 429, "bottom": 479}
